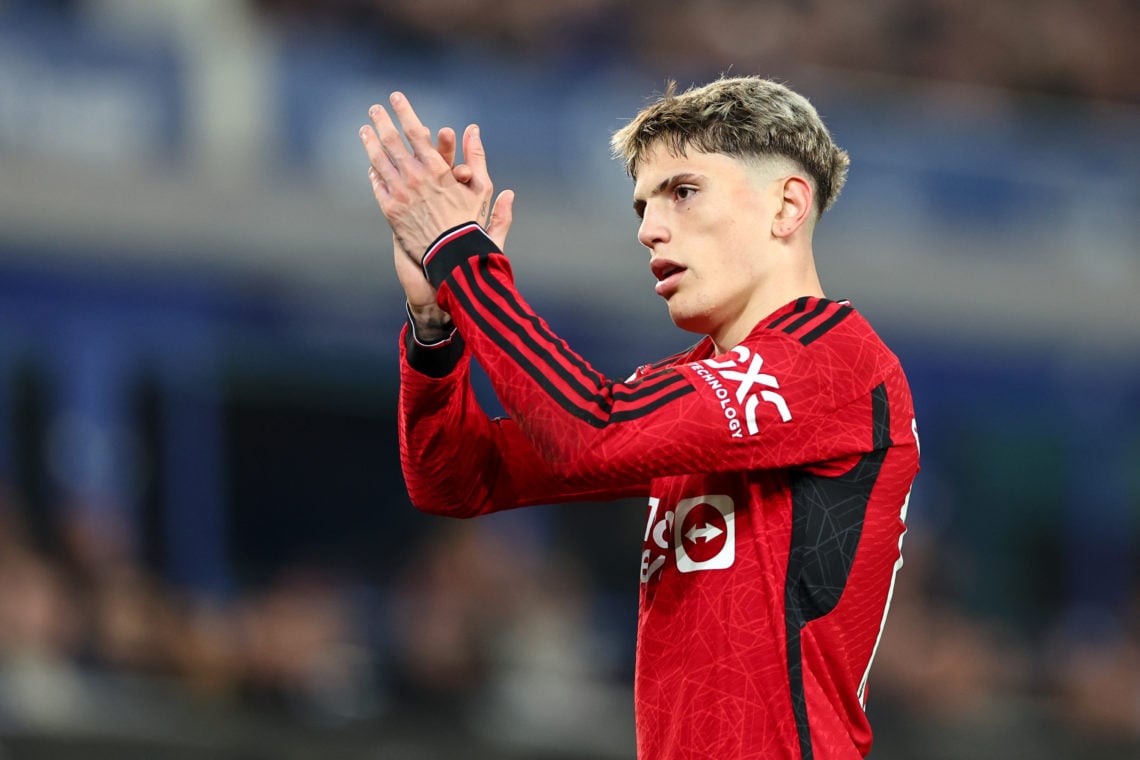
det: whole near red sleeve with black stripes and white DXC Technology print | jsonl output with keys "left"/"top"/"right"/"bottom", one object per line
{"left": 424, "top": 223, "right": 871, "bottom": 487}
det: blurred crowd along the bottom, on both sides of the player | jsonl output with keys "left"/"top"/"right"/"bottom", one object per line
{"left": 0, "top": 469, "right": 1140, "bottom": 757}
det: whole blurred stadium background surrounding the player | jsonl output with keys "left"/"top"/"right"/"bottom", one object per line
{"left": 0, "top": 0, "right": 1140, "bottom": 760}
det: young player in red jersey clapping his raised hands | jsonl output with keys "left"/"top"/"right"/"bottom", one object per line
{"left": 361, "top": 77, "right": 918, "bottom": 760}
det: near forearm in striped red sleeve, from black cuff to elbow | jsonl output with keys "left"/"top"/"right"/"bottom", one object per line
{"left": 425, "top": 226, "right": 679, "bottom": 490}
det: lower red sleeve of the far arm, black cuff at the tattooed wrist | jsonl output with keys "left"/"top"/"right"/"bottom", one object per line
{"left": 398, "top": 324, "right": 648, "bottom": 517}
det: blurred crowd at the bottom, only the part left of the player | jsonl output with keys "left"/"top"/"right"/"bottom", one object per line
{"left": 0, "top": 476, "right": 635, "bottom": 757}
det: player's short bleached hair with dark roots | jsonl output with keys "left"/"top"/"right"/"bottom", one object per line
{"left": 610, "top": 76, "right": 850, "bottom": 214}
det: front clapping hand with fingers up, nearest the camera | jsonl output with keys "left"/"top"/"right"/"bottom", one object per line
{"left": 360, "top": 92, "right": 495, "bottom": 263}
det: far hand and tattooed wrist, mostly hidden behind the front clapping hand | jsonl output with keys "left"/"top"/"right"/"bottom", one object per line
{"left": 368, "top": 126, "right": 514, "bottom": 341}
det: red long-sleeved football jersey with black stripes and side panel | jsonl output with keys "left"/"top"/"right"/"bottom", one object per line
{"left": 399, "top": 224, "right": 918, "bottom": 760}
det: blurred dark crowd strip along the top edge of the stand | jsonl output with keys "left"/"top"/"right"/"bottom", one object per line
{"left": 254, "top": 0, "right": 1140, "bottom": 101}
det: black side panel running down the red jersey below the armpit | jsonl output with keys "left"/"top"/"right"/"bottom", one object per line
{"left": 784, "top": 385, "right": 891, "bottom": 760}
